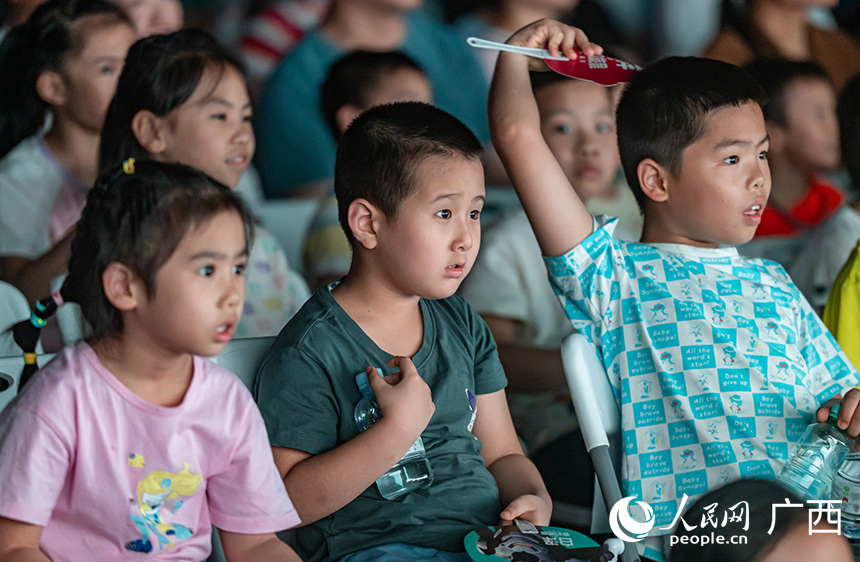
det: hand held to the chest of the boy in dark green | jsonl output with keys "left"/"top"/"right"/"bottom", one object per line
{"left": 367, "top": 357, "right": 436, "bottom": 440}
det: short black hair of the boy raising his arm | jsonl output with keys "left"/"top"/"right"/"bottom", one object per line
{"left": 616, "top": 57, "right": 764, "bottom": 210}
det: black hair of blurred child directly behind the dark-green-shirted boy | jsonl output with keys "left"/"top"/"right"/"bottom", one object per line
{"left": 320, "top": 50, "right": 424, "bottom": 139}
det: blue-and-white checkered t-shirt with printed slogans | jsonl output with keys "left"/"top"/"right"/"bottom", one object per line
{"left": 546, "top": 218, "right": 860, "bottom": 534}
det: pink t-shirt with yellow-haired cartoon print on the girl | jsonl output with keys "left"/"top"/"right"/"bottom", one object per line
{"left": 0, "top": 342, "right": 300, "bottom": 562}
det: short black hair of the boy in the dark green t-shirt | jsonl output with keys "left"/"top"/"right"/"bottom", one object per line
{"left": 334, "top": 102, "right": 482, "bottom": 243}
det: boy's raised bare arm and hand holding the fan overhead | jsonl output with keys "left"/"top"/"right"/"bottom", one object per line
{"left": 489, "top": 20, "right": 603, "bottom": 256}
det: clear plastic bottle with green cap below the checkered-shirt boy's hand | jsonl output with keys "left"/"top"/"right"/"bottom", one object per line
{"left": 776, "top": 404, "right": 851, "bottom": 500}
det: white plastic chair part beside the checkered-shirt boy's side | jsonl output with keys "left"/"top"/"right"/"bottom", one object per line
{"left": 561, "top": 333, "right": 638, "bottom": 562}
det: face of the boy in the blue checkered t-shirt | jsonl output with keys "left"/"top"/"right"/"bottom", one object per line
{"left": 660, "top": 103, "right": 771, "bottom": 247}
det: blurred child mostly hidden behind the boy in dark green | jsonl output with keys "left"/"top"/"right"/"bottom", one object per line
{"left": 304, "top": 51, "right": 433, "bottom": 289}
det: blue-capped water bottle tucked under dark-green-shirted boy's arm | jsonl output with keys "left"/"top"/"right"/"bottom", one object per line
{"left": 355, "top": 368, "right": 433, "bottom": 500}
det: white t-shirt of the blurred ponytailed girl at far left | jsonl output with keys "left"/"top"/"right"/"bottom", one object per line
{"left": 0, "top": 134, "right": 88, "bottom": 259}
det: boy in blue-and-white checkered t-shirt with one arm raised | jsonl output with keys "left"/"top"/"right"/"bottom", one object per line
{"left": 490, "top": 20, "right": 860, "bottom": 559}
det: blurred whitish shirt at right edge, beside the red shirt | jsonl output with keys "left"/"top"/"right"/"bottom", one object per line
{"left": 788, "top": 206, "right": 860, "bottom": 309}
